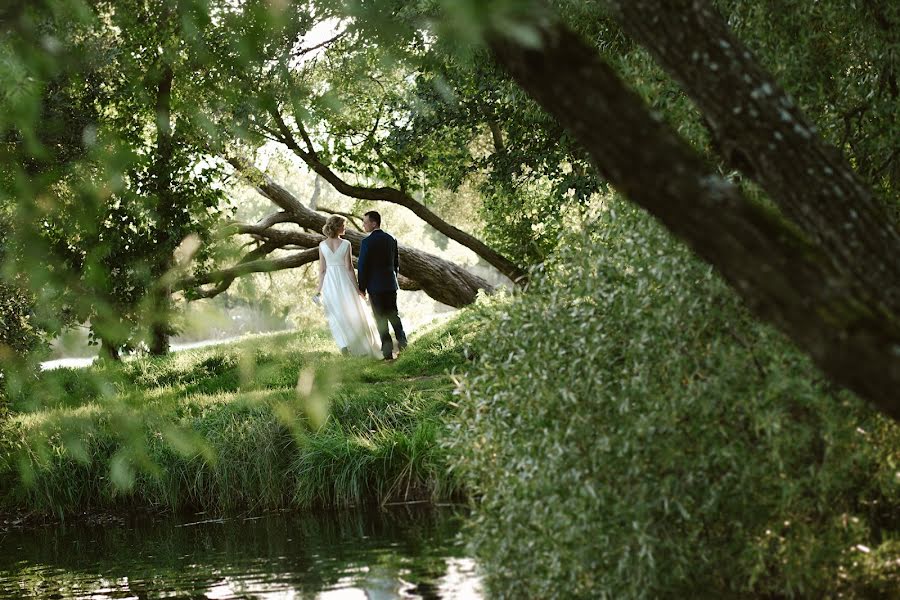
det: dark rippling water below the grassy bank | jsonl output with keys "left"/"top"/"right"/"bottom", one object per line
{"left": 0, "top": 507, "right": 483, "bottom": 600}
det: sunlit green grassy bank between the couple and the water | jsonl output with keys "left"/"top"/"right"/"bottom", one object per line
{"left": 0, "top": 315, "right": 482, "bottom": 514}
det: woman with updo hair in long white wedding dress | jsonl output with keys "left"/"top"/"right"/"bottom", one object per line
{"left": 316, "top": 215, "right": 380, "bottom": 358}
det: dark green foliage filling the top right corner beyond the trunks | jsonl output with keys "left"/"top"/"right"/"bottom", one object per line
{"left": 717, "top": 0, "right": 900, "bottom": 204}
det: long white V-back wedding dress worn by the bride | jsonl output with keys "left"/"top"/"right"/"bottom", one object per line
{"left": 319, "top": 240, "right": 381, "bottom": 358}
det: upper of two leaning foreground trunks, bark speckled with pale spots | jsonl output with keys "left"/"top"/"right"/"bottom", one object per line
{"left": 607, "top": 0, "right": 900, "bottom": 315}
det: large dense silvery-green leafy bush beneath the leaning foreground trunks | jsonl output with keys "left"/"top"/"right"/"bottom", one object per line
{"left": 448, "top": 200, "right": 900, "bottom": 598}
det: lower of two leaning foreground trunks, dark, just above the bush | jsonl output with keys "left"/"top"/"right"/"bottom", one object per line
{"left": 489, "top": 23, "right": 900, "bottom": 419}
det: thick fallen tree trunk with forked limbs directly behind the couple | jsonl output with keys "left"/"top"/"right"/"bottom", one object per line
{"left": 201, "top": 158, "right": 493, "bottom": 307}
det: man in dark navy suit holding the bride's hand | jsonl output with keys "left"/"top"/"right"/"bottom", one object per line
{"left": 357, "top": 210, "right": 406, "bottom": 360}
